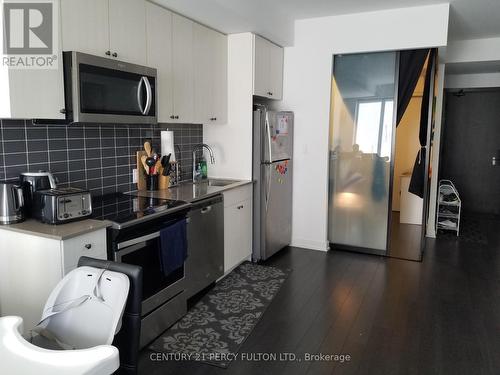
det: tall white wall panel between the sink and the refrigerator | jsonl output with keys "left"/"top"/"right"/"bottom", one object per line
{"left": 203, "top": 33, "right": 253, "bottom": 180}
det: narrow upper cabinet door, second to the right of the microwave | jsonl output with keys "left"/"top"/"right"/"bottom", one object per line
{"left": 170, "top": 13, "right": 195, "bottom": 123}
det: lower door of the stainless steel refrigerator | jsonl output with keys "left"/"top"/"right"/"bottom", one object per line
{"left": 261, "top": 160, "right": 292, "bottom": 259}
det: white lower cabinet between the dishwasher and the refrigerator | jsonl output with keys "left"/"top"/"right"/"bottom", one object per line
{"left": 224, "top": 184, "right": 253, "bottom": 273}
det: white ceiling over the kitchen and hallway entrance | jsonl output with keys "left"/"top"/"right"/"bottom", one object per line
{"left": 152, "top": 0, "right": 500, "bottom": 46}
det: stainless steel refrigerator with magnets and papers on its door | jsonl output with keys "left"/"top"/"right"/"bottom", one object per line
{"left": 252, "top": 105, "right": 293, "bottom": 261}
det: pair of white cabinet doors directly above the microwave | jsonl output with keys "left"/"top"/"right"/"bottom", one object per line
{"left": 61, "top": 0, "right": 146, "bottom": 65}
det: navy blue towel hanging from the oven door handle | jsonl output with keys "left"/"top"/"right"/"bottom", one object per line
{"left": 160, "top": 219, "right": 187, "bottom": 276}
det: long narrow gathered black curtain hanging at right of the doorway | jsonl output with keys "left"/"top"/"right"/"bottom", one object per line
{"left": 408, "top": 49, "right": 436, "bottom": 198}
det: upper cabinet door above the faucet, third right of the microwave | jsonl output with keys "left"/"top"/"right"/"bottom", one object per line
{"left": 194, "top": 23, "right": 227, "bottom": 124}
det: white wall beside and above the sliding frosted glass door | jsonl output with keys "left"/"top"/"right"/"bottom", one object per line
{"left": 282, "top": 4, "right": 449, "bottom": 250}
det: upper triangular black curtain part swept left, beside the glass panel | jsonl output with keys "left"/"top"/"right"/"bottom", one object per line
{"left": 396, "top": 49, "right": 429, "bottom": 126}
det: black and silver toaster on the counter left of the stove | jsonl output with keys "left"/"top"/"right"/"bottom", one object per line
{"left": 32, "top": 188, "right": 92, "bottom": 224}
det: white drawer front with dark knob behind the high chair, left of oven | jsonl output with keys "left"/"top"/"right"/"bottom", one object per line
{"left": 62, "top": 229, "right": 107, "bottom": 274}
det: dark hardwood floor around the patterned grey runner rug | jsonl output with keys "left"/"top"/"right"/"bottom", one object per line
{"left": 140, "top": 220, "right": 500, "bottom": 375}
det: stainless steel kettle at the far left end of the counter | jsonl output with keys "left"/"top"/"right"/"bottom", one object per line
{"left": 0, "top": 180, "right": 24, "bottom": 224}
